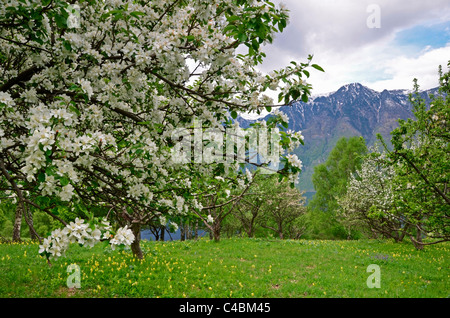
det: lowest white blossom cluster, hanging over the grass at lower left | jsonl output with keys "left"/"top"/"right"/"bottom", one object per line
{"left": 39, "top": 218, "right": 135, "bottom": 259}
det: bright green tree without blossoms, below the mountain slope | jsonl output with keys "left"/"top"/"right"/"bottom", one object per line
{"left": 307, "top": 137, "right": 367, "bottom": 238}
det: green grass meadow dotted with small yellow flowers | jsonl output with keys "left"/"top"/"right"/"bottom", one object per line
{"left": 0, "top": 238, "right": 450, "bottom": 298}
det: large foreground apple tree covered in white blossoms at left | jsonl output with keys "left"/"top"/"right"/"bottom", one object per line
{"left": 0, "top": 0, "right": 323, "bottom": 257}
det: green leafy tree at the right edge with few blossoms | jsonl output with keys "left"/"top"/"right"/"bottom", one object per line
{"left": 378, "top": 69, "right": 450, "bottom": 249}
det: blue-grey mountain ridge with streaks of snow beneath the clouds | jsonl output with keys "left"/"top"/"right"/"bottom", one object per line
{"left": 238, "top": 83, "right": 438, "bottom": 195}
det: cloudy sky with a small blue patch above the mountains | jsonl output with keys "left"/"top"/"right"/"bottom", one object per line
{"left": 260, "top": 0, "right": 450, "bottom": 95}
